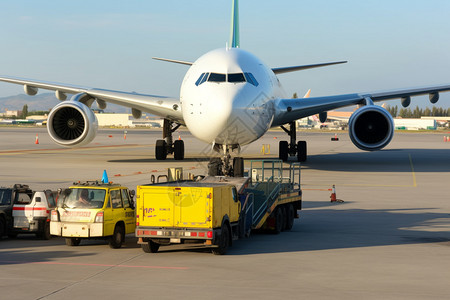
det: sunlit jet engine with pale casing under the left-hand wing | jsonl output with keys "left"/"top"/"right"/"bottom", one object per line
{"left": 47, "top": 100, "right": 98, "bottom": 147}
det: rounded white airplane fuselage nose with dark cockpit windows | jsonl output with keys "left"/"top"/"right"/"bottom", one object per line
{"left": 180, "top": 48, "right": 285, "bottom": 149}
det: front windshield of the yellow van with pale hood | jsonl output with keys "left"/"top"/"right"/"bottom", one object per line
{"left": 58, "top": 188, "right": 106, "bottom": 209}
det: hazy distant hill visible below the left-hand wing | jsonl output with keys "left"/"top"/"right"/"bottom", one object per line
{"left": 0, "top": 93, "right": 130, "bottom": 113}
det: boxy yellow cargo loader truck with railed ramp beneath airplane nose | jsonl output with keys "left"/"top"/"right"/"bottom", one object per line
{"left": 136, "top": 160, "right": 302, "bottom": 254}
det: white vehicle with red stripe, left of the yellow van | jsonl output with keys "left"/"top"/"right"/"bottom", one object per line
{"left": 9, "top": 190, "right": 58, "bottom": 240}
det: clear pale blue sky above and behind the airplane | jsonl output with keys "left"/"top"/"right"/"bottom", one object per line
{"left": 0, "top": 0, "right": 450, "bottom": 107}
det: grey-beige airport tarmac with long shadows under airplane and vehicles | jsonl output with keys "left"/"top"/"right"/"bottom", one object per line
{"left": 0, "top": 127, "right": 450, "bottom": 299}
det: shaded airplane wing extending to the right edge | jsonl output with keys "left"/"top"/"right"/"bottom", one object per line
{"left": 272, "top": 84, "right": 450, "bottom": 127}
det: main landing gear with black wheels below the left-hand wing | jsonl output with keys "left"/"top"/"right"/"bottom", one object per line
{"left": 155, "top": 119, "right": 184, "bottom": 160}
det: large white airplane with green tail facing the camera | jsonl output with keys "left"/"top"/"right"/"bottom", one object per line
{"left": 0, "top": 0, "right": 450, "bottom": 176}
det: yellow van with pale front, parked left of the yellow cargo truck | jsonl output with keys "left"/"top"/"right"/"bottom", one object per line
{"left": 50, "top": 181, "right": 136, "bottom": 248}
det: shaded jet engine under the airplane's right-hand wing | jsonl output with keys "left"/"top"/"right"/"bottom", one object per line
{"left": 348, "top": 105, "right": 394, "bottom": 151}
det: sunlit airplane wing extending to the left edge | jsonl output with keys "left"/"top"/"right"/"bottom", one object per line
{"left": 0, "top": 76, "right": 184, "bottom": 124}
